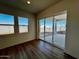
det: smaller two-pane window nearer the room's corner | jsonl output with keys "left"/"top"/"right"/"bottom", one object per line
{"left": 18, "top": 17, "right": 28, "bottom": 33}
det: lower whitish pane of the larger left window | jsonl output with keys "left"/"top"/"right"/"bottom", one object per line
{"left": 0, "top": 25, "right": 14, "bottom": 35}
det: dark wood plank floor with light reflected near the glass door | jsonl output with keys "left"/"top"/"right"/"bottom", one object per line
{"left": 0, "top": 40, "right": 74, "bottom": 59}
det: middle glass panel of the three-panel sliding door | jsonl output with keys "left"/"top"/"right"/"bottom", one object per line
{"left": 45, "top": 17, "right": 53, "bottom": 43}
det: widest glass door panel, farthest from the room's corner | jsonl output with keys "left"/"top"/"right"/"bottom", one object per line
{"left": 54, "top": 14, "right": 66, "bottom": 49}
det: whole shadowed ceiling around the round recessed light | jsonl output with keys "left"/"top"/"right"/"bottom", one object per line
{"left": 0, "top": 0, "right": 61, "bottom": 13}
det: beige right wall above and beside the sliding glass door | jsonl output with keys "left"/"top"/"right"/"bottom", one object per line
{"left": 38, "top": 0, "right": 79, "bottom": 59}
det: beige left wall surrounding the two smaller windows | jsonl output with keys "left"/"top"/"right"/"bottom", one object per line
{"left": 0, "top": 6, "right": 35, "bottom": 49}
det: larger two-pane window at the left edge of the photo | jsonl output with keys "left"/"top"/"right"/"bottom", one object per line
{"left": 0, "top": 13, "right": 14, "bottom": 35}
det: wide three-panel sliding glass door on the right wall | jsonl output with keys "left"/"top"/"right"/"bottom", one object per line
{"left": 39, "top": 13, "right": 67, "bottom": 49}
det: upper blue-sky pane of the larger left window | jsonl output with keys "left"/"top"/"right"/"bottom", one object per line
{"left": 0, "top": 13, "right": 14, "bottom": 24}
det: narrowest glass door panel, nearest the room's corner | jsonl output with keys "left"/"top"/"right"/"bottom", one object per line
{"left": 39, "top": 19, "right": 45, "bottom": 40}
